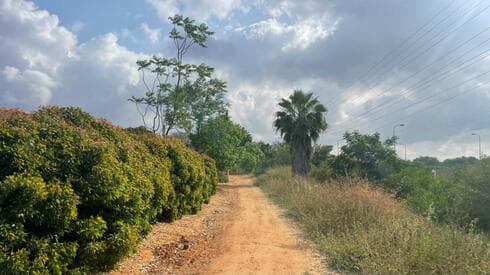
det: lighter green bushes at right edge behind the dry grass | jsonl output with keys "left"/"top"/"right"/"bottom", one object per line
{"left": 379, "top": 158, "right": 490, "bottom": 231}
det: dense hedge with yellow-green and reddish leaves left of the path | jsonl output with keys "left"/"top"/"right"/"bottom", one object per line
{"left": 0, "top": 107, "right": 217, "bottom": 274}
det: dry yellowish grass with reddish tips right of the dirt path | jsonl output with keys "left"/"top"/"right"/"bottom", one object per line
{"left": 257, "top": 168, "right": 490, "bottom": 274}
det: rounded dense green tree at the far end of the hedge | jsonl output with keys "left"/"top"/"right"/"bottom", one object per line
{"left": 190, "top": 116, "right": 251, "bottom": 171}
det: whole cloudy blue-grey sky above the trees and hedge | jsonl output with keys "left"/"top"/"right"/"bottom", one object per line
{"left": 0, "top": 0, "right": 490, "bottom": 159}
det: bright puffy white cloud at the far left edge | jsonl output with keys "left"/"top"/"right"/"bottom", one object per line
{"left": 0, "top": 0, "right": 77, "bottom": 109}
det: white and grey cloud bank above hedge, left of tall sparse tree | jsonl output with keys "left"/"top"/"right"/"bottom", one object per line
{"left": 0, "top": 0, "right": 147, "bottom": 125}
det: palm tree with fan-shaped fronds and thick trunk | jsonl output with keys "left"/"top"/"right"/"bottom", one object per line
{"left": 274, "top": 90, "right": 327, "bottom": 176}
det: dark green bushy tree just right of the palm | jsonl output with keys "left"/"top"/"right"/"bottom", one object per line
{"left": 332, "top": 132, "right": 402, "bottom": 181}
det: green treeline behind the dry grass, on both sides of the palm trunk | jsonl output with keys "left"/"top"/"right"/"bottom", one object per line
{"left": 255, "top": 132, "right": 490, "bottom": 231}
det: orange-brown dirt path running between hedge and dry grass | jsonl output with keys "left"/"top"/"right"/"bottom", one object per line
{"left": 113, "top": 176, "right": 325, "bottom": 274}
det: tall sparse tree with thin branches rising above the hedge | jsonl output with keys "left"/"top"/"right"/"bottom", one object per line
{"left": 129, "top": 15, "right": 226, "bottom": 135}
